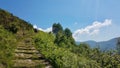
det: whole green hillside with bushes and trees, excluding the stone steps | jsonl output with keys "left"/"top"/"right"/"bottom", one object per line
{"left": 0, "top": 9, "right": 120, "bottom": 68}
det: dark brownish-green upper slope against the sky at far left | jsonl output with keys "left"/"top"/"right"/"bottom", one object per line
{"left": 0, "top": 9, "right": 33, "bottom": 33}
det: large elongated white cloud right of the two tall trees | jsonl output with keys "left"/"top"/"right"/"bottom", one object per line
{"left": 73, "top": 19, "right": 112, "bottom": 41}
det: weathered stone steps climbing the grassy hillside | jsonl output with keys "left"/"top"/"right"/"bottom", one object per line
{"left": 13, "top": 40, "right": 53, "bottom": 68}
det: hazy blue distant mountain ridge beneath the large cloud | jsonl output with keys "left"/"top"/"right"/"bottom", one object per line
{"left": 76, "top": 37, "right": 120, "bottom": 50}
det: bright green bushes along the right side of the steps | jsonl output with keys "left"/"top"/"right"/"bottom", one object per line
{"left": 34, "top": 31, "right": 99, "bottom": 68}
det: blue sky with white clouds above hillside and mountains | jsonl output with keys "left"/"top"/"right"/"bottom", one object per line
{"left": 0, "top": 0, "right": 120, "bottom": 41}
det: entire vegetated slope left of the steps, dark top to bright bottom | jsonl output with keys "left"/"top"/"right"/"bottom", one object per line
{"left": 0, "top": 9, "right": 33, "bottom": 68}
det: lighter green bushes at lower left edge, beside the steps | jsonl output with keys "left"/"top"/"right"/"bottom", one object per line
{"left": 0, "top": 26, "right": 16, "bottom": 68}
